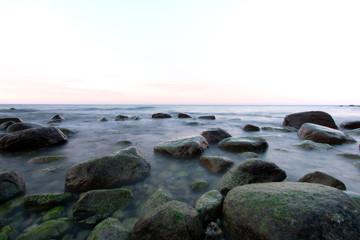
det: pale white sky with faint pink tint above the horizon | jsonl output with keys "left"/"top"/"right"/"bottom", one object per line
{"left": 0, "top": 0, "right": 360, "bottom": 104}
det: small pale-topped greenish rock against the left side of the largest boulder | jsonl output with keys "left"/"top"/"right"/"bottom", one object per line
{"left": 195, "top": 190, "right": 223, "bottom": 224}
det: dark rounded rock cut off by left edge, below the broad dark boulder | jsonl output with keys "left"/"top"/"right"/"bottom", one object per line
{"left": 0, "top": 170, "right": 25, "bottom": 203}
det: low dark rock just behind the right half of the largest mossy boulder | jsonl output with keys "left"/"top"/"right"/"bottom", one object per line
{"left": 298, "top": 171, "right": 346, "bottom": 190}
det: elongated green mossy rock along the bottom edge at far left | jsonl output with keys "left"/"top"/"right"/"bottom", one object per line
{"left": 16, "top": 218, "right": 73, "bottom": 240}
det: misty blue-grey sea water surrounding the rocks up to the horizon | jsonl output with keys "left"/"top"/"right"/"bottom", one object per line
{"left": 0, "top": 104, "right": 360, "bottom": 236}
